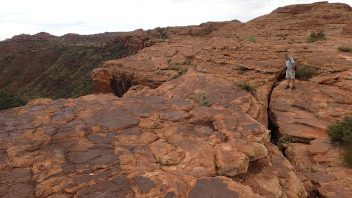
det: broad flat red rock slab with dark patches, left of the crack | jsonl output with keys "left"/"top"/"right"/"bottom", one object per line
{"left": 0, "top": 94, "right": 280, "bottom": 197}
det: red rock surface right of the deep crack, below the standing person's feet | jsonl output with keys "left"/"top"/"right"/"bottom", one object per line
{"left": 271, "top": 81, "right": 352, "bottom": 197}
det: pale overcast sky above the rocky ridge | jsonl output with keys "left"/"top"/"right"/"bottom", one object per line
{"left": 0, "top": 0, "right": 352, "bottom": 40}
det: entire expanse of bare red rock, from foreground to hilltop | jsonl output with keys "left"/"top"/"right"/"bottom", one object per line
{"left": 0, "top": 2, "right": 352, "bottom": 198}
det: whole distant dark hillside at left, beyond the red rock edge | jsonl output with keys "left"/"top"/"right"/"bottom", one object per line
{"left": 0, "top": 31, "right": 155, "bottom": 102}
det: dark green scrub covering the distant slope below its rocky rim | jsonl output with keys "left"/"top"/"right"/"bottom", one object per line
{"left": 0, "top": 40, "right": 136, "bottom": 100}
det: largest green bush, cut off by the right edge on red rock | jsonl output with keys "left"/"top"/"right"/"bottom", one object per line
{"left": 328, "top": 116, "right": 352, "bottom": 166}
